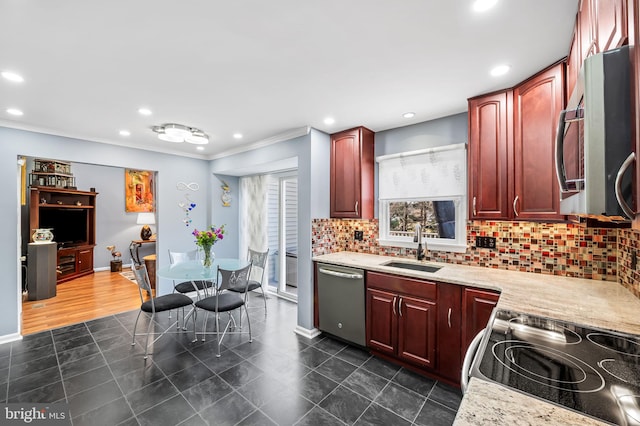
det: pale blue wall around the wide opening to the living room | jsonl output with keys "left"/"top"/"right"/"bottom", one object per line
{"left": 0, "top": 127, "right": 214, "bottom": 342}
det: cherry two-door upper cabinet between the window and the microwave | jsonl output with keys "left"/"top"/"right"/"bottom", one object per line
{"left": 469, "top": 63, "right": 564, "bottom": 220}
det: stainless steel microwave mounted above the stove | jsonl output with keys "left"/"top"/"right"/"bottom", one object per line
{"left": 555, "top": 46, "right": 635, "bottom": 218}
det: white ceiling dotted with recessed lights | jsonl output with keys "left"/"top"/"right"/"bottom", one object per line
{"left": 0, "top": 0, "right": 578, "bottom": 158}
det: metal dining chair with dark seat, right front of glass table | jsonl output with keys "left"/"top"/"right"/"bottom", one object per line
{"left": 194, "top": 262, "right": 253, "bottom": 357}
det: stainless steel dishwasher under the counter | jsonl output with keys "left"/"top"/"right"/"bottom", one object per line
{"left": 318, "top": 263, "right": 366, "bottom": 346}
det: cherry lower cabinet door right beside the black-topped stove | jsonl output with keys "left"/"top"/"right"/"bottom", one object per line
{"left": 462, "top": 288, "right": 499, "bottom": 356}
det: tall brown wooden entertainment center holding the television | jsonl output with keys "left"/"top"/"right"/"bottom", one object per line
{"left": 29, "top": 186, "right": 98, "bottom": 284}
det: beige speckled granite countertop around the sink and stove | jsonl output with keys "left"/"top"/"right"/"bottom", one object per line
{"left": 313, "top": 252, "right": 640, "bottom": 425}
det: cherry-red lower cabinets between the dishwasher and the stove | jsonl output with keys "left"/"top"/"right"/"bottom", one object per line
{"left": 366, "top": 272, "right": 498, "bottom": 385}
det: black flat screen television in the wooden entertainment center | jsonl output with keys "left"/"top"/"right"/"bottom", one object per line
{"left": 40, "top": 208, "right": 89, "bottom": 247}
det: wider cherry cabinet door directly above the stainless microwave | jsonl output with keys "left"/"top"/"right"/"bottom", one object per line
{"left": 592, "top": 0, "right": 627, "bottom": 52}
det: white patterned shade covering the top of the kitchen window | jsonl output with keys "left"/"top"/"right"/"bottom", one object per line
{"left": 376, "top": 143, "right": 467, "bottom": 200}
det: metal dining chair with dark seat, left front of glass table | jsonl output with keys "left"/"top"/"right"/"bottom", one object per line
{"left": 131, "top": 264, "right": 196, "bottom": 359}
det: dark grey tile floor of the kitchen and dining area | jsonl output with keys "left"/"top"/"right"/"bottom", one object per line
{"left": 0, "top": 296, "right": 461, "bottom": 426}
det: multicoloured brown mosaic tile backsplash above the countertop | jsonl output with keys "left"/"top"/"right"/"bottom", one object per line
{"left": 312, "top": 219, "right": 628, "bottom": 282}
